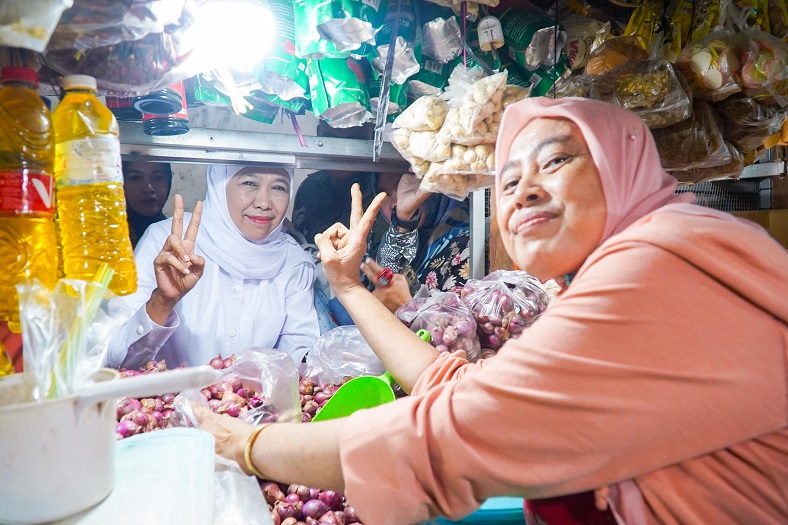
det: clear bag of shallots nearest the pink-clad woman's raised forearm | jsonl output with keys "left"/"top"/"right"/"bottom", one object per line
{"left": 397, "top": 292, "right": 481, "bottom": 362}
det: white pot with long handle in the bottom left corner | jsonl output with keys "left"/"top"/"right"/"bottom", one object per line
{"left": 0, "top": 365, "right": 216, "bottom": 525}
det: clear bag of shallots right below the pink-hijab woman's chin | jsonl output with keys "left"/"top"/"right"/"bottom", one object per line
{"left": 460, "top": 270, "right": 549, "bottom": 357}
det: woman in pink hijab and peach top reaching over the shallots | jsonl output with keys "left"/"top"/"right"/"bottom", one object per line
{"left": 199, "top": 98, "right": 788, "bottom": 524}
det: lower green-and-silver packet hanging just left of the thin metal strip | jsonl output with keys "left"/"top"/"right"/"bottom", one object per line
{"left": 307, "top": 58, "right": 372, "bottom": 128}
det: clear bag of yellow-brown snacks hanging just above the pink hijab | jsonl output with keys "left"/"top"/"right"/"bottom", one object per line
{"left": 591, "top": 60, "right": 692, "bottom": 129}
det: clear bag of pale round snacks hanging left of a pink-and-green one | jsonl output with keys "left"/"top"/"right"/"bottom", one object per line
{"left": 676, "top": 29, "right": 741, "bottom": 101}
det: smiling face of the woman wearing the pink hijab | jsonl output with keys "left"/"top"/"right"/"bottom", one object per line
{"left": 497, "top": 118, "right": 607, "bottom": 280}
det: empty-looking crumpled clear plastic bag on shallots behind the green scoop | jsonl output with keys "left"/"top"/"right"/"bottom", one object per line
{"left": 302, "top": 326, "right": 386, "bottom": 385}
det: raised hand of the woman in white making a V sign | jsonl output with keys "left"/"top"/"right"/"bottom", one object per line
{"left": 147, "top": 195, "right": 205, "bottom": 325}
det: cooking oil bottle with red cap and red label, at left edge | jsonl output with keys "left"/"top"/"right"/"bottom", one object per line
{"left": 0, "top": 67, "right": 57, "bottom": 332}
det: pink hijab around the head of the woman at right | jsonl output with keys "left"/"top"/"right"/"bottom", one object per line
{"left": 495, "top": 97, "right": 695, "bottom": 241}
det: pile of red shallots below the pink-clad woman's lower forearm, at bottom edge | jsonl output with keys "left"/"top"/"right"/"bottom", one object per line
{"left": 260, "top": 481, "right": 361, "bottom": 525}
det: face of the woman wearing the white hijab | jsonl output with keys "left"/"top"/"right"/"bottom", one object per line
{"left": 226, "top": 167, "right": 290, "bottom": 242}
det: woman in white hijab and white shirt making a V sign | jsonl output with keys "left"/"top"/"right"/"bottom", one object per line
{"left": 107, "top": 165, "right": 318, "bottom": 368}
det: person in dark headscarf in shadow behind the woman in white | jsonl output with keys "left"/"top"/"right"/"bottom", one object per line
{"left": 123, "top": 161, "right": 172, "bottom": 247}
